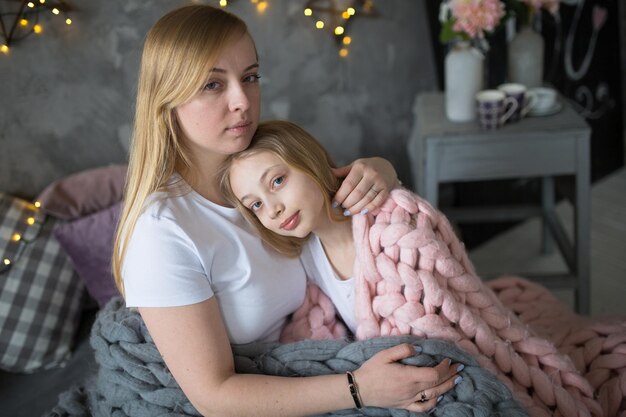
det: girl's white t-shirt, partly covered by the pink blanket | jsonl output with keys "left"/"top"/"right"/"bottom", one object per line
{"left": 300, "top": 234, "right": 356, "bottom": 333}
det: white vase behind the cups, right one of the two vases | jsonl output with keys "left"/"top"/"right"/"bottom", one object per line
{"left": 508, "top": 26, "right": 544, "bottom": 88}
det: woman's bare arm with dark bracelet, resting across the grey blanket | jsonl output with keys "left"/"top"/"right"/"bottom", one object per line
{"left": 139, "top": 297, "right": 456, "bottom": 417}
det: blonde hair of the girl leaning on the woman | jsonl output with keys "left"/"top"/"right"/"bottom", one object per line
{"left": 220, "top": 120, "right": 348, "bottom": 257}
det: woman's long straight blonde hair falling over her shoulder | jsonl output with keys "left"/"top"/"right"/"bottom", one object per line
{"left": 112, "top": 5, "right": 249, "bottom": 294}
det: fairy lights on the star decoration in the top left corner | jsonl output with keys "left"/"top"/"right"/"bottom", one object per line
{"left": 0, "top": 0, "right": 73, "bottom": 55}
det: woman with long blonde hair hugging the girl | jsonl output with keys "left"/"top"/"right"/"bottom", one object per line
{"left": 113, "top": 6, "right": 455, "bottom": 416}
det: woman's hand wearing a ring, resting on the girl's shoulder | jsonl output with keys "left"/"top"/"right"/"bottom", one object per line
{"left": 333, "top": 157, "right": 398, "bottom": 215}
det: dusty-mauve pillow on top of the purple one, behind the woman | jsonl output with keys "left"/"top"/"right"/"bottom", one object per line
{"left": 37, "top": 165, "right": 127, "bottom": 220}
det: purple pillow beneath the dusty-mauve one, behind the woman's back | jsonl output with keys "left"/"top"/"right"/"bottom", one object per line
{"left": 54, "top": 202, "right": 122, "bottom": 307}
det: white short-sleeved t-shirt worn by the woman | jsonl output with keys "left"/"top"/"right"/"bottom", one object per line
{"left": 122, "top": 175, "right": 306, "bottom": 344}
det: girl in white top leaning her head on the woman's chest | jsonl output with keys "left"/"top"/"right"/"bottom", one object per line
{"left": 220, "top": 121, "right": 380, "bottom": 333}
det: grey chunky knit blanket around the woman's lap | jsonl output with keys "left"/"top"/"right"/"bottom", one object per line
{"left": 47, "top": 298, "right": 527, "bottom": 417}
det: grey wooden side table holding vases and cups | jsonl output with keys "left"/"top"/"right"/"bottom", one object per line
{"left": 408, "top": 93, "right": 591, "bottom": 314}
